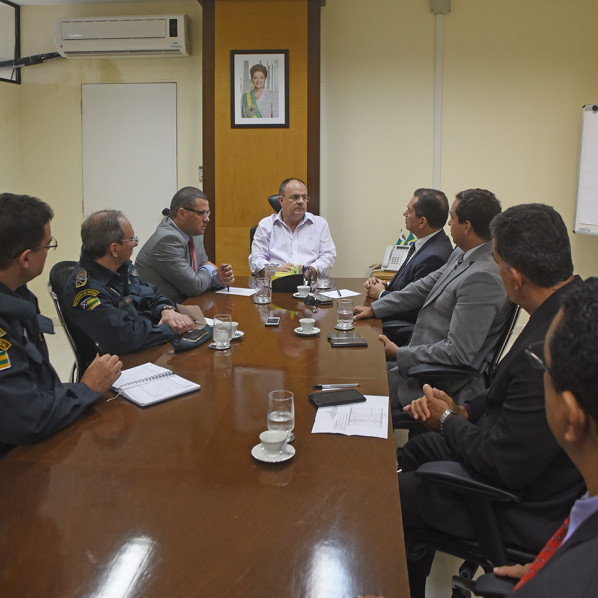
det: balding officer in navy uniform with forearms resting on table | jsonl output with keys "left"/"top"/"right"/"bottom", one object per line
{"left": 63, "top": 210, "right": 195, "bottom": 354}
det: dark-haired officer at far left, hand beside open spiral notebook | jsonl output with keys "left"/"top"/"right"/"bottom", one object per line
{"left": 0, "top": 193, "right": 122, "bottom": 456}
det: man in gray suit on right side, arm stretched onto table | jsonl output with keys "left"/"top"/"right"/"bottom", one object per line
{"left": 355, "top": 189, "right": 510, "bottom": 422}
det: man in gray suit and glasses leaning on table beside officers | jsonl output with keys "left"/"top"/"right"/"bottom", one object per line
{"left": 135, "top": 187, "right": 235, "bottom": 303}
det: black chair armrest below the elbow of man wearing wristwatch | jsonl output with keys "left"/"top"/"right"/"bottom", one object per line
{"left": 415, "top": 461, "right": 520, "bottom": 502}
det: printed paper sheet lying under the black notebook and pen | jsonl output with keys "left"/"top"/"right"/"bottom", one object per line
{"left": 311, "top": 395, "right": 388, "bottom": 438}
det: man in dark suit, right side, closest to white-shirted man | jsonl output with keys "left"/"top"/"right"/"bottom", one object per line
{"left": 364, "top": 189, "right": 453, "bottom": 345}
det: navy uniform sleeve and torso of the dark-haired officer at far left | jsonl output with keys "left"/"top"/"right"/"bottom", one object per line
{"left": 0, "top": 282, "right": 102, "bottom": 456}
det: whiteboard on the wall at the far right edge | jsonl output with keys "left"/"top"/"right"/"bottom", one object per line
{"left": 574, "top": 104, "right": 598, "bottom": 235}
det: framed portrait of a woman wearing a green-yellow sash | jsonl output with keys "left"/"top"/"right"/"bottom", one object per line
{"left": 230, "top": 50, "right": 289, "bottom": 128}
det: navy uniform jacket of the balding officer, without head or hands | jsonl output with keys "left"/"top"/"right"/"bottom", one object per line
{"left": 62, "top": 252, "right": 176, "bottom": 355}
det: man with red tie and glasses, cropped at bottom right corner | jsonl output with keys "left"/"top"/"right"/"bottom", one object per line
{"left": 494, "top": 278, "right": 598, "bottom": 598}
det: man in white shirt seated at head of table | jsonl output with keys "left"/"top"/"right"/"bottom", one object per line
{"left": 249, "top": 178, "right": 336, "bottom": 275}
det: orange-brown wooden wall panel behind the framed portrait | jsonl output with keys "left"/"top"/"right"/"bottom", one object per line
{"left": 211, "top": 0, "right": 309, "bottom": 275}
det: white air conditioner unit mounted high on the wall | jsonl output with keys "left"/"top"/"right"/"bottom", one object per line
{"left": 55, "top": 15, "right": 190, "bottom": 58}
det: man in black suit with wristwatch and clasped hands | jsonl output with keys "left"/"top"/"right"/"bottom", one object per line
{"left": 399, "top": 204, "right": 584, "bottom": 598}
